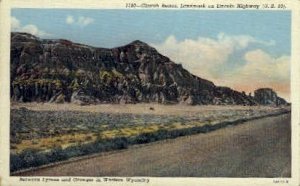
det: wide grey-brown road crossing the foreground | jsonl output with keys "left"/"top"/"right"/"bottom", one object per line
{"left": 17, "top": 114, "right": 291, "bottom": 177}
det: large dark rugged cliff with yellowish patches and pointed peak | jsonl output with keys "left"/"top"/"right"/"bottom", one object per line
{"left": 11, "top": 33, "right": 288, "bottom": 105}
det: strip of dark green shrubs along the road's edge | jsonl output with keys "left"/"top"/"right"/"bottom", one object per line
{"left": 10, "top": 122, "right": 239, "bottom": 171}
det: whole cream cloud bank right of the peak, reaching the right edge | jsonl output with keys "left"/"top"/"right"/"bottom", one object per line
{"left": 152, "top": 33, "right": 290, "bottom": 99}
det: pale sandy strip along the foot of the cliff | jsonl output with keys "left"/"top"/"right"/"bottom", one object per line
{"left": 11, "top": 103, "right": 290, "bottom": 115}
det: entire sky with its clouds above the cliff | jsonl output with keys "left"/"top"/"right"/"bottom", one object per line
{"left": 11, "top": 9, "right": 291, "bottom": 99}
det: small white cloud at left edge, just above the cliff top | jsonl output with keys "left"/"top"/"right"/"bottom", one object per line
{"left": 11, "top": 16, "right": 51, "bottom": 37}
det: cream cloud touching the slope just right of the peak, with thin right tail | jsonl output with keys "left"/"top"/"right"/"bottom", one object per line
{"left": 153, "top": 33, "right": 272, "bottom": 78}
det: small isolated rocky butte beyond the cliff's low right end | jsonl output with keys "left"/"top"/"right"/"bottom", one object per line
{"left": 254, "top": 88, "right": 288, "bottom": 106}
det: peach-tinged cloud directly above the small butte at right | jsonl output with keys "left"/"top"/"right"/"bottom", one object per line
{"left": 233, "top": 49, "right": 291, "bottom": 100}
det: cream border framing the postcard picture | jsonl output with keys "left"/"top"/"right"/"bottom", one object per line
{"left": 0, "top": 0, "right": 300, "bottom": 186}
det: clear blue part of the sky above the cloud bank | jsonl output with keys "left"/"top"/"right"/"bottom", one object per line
{"left": 12, "top": 9, "right": 291, "bottom": 54}
